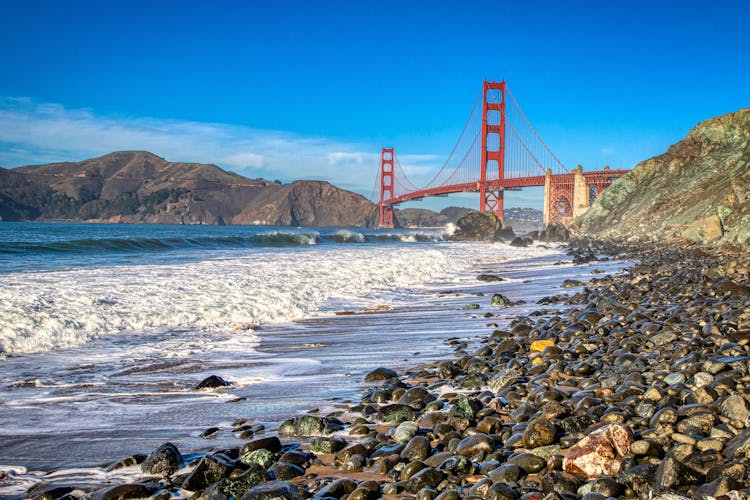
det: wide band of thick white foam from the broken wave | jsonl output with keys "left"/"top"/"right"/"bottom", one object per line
{"left": 0, "top": 241, "right": 547, "bottom": 353}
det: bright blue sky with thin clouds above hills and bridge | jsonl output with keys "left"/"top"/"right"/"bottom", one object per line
{"left": 0, "top": 0, "right": 750, "bottom": 208}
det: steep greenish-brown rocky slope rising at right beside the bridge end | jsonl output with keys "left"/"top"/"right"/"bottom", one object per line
{"left": 573, "top": 108, "right": 750, "bottom": 243}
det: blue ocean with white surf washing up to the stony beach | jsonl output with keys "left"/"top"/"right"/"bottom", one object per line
{"left": 0, "top": 222, "right": 624, "bottom": 492}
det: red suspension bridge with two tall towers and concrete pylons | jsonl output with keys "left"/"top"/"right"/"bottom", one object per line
{"left": 371, "top": 80, "right": 628, "bottom": 227}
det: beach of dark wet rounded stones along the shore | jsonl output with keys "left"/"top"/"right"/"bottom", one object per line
{"left": 14, "top": 240, "right": 750, "bottom": 500}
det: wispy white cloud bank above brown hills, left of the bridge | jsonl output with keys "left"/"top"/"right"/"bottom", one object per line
{"left": 0, "top": 97, "right": 379, "bottom": 196}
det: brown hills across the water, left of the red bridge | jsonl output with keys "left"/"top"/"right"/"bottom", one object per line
{"left": 0, "top": 151, "right": 376, "bottom": 226}
